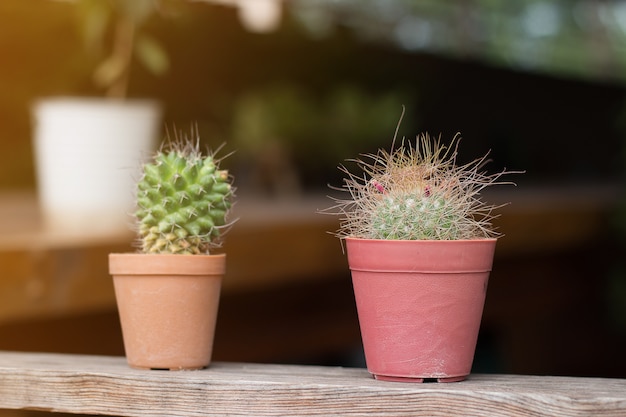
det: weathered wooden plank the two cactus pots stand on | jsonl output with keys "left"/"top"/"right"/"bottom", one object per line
{"left": 0, "top": 352, "right": 626, "bottom": 417}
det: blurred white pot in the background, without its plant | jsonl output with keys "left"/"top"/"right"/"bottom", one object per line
{"left": 33, "top": 97, "right": 161, "bottom": 235}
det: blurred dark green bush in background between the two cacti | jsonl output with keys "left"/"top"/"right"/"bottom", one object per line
{"left": 231, "top": 84, "right": 417, "bottom": 193}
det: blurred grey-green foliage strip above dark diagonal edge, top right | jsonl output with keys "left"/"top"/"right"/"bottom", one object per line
{"left": 293, "top": 0, "right": 626, "bottom": 82}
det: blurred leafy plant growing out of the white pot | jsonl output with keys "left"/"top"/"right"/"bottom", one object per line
{"left": 76, "top": 0, "right": 170, "bottom": 98}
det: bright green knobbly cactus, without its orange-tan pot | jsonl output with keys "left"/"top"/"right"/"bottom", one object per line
{"left": 135, "top": 136, "right": 234, "bottom": 254}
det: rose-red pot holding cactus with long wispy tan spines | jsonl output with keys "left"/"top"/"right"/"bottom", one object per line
{"left": 324, "top": 127, "right": 508, "bottom": 382}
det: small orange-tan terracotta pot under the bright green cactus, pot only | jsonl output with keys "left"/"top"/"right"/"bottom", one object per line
{"left": 109, "top": 253, "right": 226, "bottom": 370}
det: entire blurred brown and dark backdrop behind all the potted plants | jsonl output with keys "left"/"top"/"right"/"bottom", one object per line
{"left": 0, "top": 0, "right": 626, "bottom": 386}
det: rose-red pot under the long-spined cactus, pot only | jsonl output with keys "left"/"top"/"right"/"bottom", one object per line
{"left": 346, "top": 238, "right": 496, "bottom": 382}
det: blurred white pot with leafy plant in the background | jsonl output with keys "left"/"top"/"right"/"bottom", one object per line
{"left": 32, "top": 0, "right": 169, "bottom": 236}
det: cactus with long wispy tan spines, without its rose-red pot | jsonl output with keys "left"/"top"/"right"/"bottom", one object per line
{"left": 326, "top": 130, "right": 510, "bottom": 240}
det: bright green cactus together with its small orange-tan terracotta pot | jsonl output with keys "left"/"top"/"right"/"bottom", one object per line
{"left": 109, "top": 129, "right": 235, "bottom": 370}
